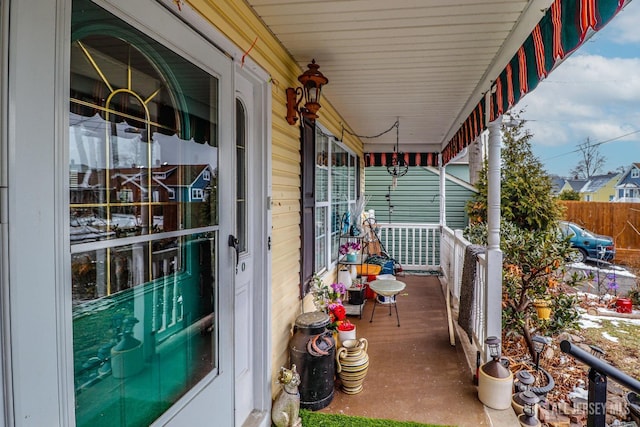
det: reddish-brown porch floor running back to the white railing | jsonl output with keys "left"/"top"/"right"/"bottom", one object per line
{"left": 320, "top": 274, "right": 491, "bottom": 427}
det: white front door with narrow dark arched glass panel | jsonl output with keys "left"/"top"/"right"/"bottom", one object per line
{"left": 234, "top": 71, "right": 268, "bottom": 426}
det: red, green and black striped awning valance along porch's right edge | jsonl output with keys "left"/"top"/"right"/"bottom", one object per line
{"left": 442, "top": 0, "right": 626, "bottom": 164}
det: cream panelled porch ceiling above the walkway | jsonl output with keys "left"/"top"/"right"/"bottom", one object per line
{"left": 247, "top": 0, "right": 551, "bottom": 152}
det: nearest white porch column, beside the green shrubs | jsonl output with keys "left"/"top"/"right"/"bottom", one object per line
{"left": 484, "top": 108, "right": 502, "bottom": 360}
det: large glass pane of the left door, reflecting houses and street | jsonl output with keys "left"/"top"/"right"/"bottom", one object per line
{"left": 69, "top": 0, "right": 218, "bottom": 426}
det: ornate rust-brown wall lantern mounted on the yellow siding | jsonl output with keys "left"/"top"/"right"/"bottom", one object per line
{"left": 286, "top": 59, "right": 329, "bottom": 125}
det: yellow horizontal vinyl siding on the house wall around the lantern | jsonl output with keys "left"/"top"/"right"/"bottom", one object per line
{"left": 189, "top": 0, "right": 363, "bottom": 398}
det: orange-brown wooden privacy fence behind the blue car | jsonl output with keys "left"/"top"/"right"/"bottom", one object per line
{"left": 561, "top": 201, "right": 640, "bottom": 267}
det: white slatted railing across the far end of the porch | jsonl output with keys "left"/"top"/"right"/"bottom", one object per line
{"left": 377, "top": 223, "right": 440, "bottom": 270}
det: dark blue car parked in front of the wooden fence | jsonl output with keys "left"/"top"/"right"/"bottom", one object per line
{"left": 560, "top": 221, "right": 616, "bottom": 262}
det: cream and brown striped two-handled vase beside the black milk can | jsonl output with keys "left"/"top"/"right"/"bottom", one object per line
{"left": 336, "top": 338, "right": 369, "bottom": 394}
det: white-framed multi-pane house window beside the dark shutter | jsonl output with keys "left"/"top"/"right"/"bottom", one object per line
{"left": 315, "top": 128, "right": 358, "bottom": 272}
